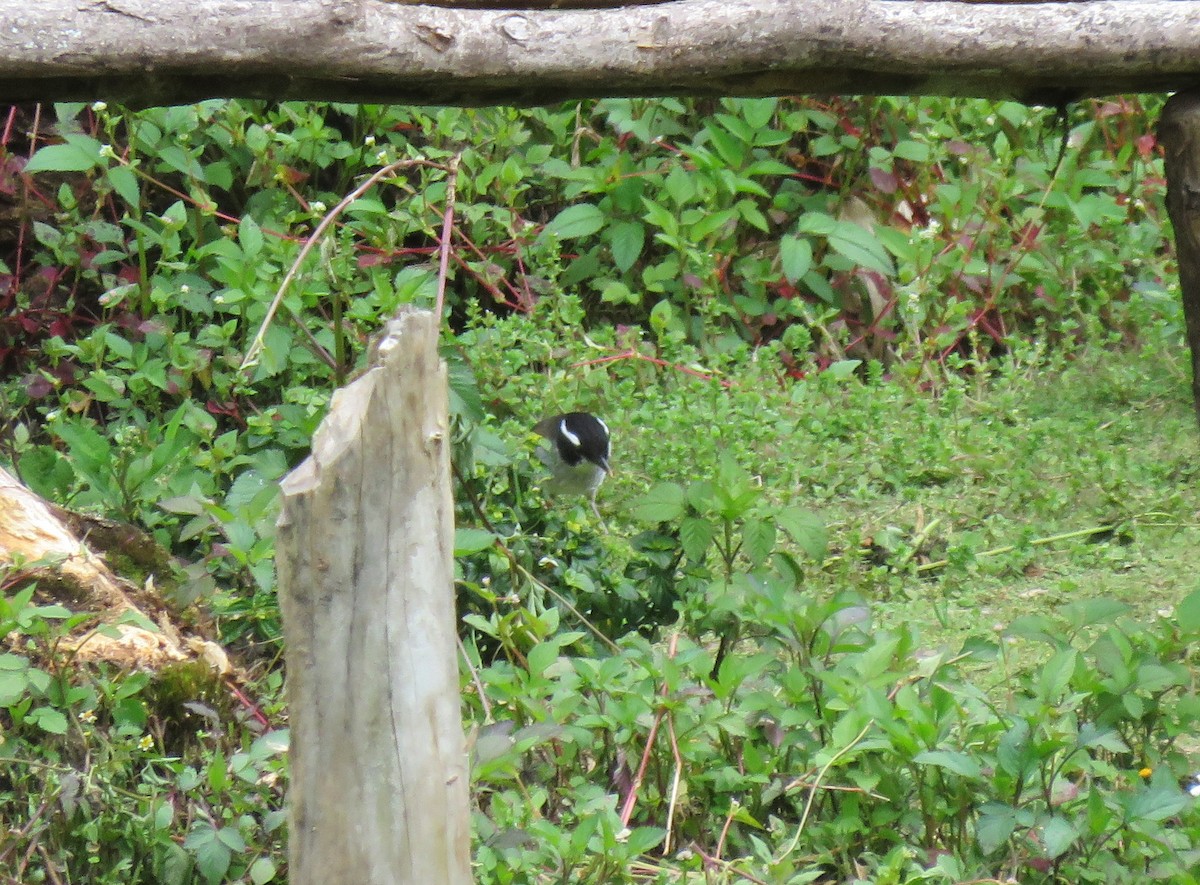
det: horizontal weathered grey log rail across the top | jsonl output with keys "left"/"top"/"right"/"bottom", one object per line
{"left": 0, "top": 0, "right": 1200, "bottom": 104}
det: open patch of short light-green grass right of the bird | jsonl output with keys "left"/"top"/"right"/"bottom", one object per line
{"left": 513, "top": 323, "right": 1200, "bottom": 642}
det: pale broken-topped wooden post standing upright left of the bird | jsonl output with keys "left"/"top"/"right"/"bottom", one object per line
{"left": 276, "top": 312, "right": 470, "bottom": 885}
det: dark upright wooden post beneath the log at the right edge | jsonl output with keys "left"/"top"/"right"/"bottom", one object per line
{"left": 1158, "top": 92, "right": 1200, "bottom": 421}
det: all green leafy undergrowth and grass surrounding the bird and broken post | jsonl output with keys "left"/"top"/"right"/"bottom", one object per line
{"left": 0, "top": 96, "right": 1200, "bottom": 885}
